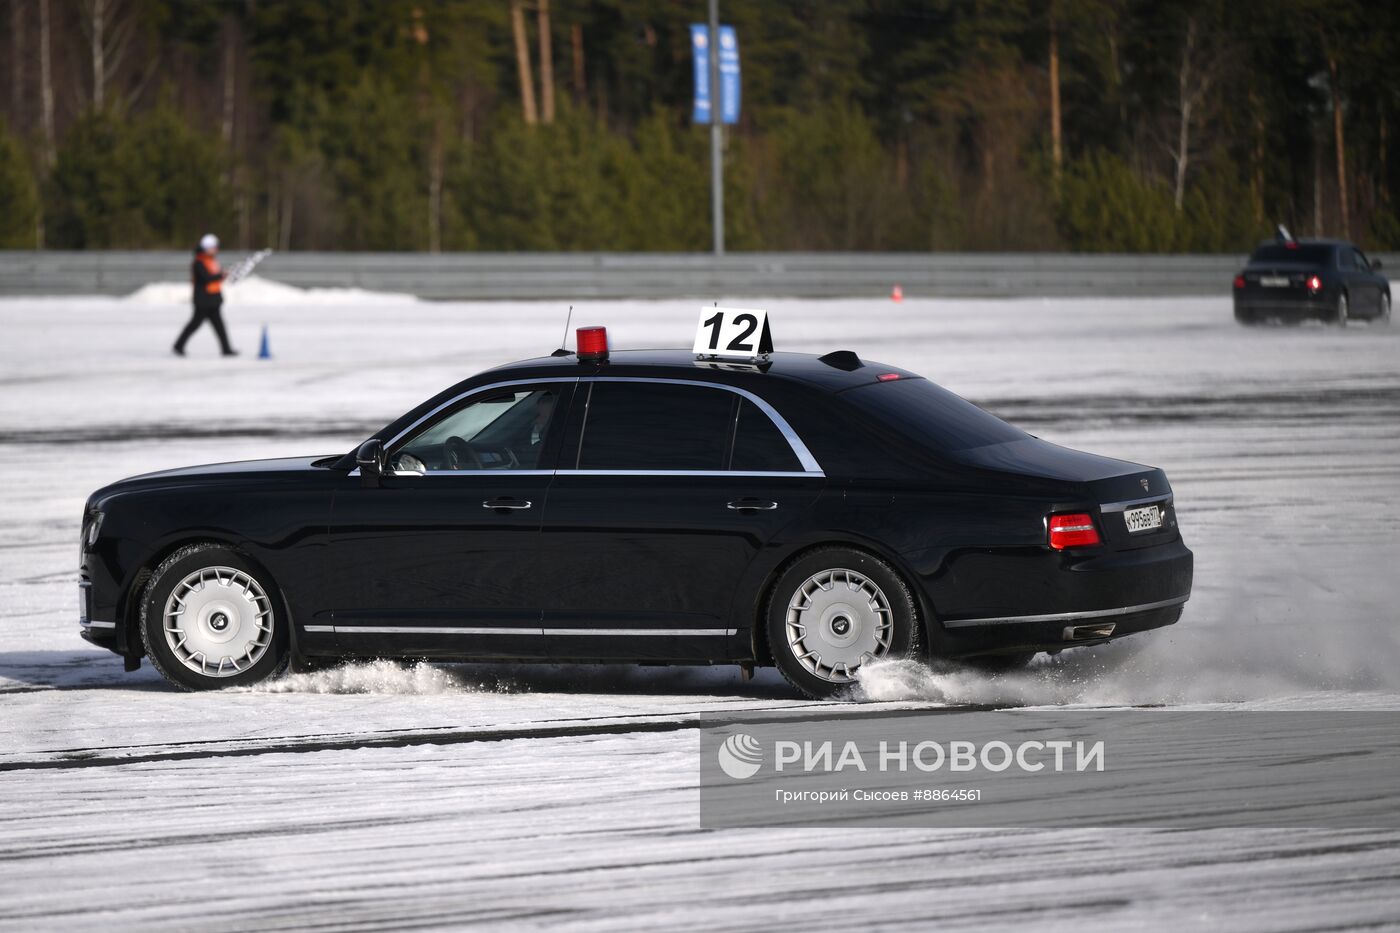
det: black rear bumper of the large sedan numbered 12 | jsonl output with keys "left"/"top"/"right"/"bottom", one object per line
{"left": 930, "top": 538, "right": 1194, "bottom": 657}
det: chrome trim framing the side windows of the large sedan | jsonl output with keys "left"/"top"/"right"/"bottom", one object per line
{"left": 366, "top": 375, "right": 826, "bottom": 478}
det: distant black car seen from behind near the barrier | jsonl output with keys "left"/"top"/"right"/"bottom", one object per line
{"left": 1235, "top": 240, "right": 1390, "bottom": 326}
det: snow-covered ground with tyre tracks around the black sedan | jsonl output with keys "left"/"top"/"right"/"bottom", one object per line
{"left": 0, "top": 279, "right": 1400, "bottom": 930}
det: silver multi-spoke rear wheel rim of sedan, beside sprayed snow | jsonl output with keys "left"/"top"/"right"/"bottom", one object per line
{"left": 785, "top": 567, "right": 895, "bottom": 684}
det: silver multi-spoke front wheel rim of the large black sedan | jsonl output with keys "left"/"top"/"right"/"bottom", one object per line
{"left": 162, "top": 567, "right": 273, "bottom": 677}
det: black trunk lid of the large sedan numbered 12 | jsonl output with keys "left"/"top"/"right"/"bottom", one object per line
{"left": 949, "top": 437, "right": 1172, "bottom": 503}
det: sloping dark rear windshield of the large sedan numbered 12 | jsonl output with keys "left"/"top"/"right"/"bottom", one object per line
{"left": 846, "top": 378, "right": 1026, "bottom": 452}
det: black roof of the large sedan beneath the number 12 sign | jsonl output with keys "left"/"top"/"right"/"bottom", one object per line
{"left": 473, "top": 350, "right": 916, "bottom": 392}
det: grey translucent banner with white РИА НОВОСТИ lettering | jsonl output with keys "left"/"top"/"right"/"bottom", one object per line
{"left": 700, "top": 710, "right": 1400, "bottom": 828}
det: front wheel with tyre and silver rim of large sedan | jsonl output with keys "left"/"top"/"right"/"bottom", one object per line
{"left": 141, "top": 545, "right": 287, "bottom": 691}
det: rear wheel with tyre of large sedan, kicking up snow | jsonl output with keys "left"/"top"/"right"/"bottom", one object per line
{"left": 767, "top": 548, "right": 920, "bottom": 699}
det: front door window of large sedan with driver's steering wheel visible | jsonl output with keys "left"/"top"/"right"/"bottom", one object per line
{"left": 391, "top": 387, "right": 560, "bottom": 472}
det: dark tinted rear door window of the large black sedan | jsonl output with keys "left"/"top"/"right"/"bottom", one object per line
{"left": 578, "top": 382, "right": 735, "bottom": 471}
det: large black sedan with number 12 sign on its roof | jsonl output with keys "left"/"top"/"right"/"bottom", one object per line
{"left": 80, "top": 332, "right": 1191, "bottom": 696}
